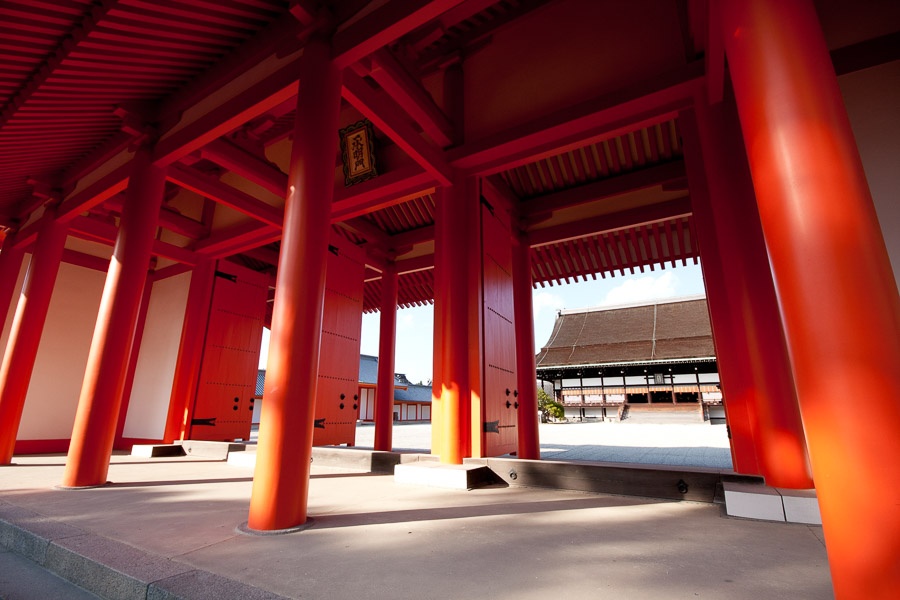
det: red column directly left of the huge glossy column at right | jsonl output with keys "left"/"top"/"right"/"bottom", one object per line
{"left": 682, "top": 103, "right": 813, "bottom": 489}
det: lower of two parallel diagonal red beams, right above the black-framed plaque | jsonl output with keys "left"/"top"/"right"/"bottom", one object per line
{"left": 343, "top": 70, "right": 458, "bottom": 185}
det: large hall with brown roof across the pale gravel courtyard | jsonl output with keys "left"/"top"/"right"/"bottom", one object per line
{"left": 536, "top": 297, "right": 724, "bottom": 422}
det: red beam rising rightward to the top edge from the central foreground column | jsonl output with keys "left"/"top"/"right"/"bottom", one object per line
{"left": 331, "top": 0, "right": 472, "bottom": 67}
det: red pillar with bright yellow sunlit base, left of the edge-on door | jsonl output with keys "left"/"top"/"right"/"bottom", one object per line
{"left": 431, "top": 177, "right": 482, "bottom": 464}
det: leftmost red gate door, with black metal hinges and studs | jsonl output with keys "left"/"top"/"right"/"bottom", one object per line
{"left": 187, "top": 261, "right": 269, "bottom": 441}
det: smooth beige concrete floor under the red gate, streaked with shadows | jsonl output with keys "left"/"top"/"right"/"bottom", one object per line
{"left": 0, "top": 428, "right": 833, "bottom": 600}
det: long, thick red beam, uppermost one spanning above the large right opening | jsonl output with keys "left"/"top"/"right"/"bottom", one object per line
{"left": 447, "top": 62, "right": 704, "bottom": 175}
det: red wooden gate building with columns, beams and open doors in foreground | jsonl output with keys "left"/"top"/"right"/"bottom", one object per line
{"left": 0, "top": 0, "right": 900, "bottom": 599}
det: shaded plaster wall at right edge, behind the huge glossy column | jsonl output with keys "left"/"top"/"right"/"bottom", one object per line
{"left": 838, "top": 61, "right": 900, "bottom": 287}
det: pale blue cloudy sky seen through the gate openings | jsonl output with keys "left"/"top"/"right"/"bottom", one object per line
{"left": 260, "top": 264, "right": 704, "bottom": 383}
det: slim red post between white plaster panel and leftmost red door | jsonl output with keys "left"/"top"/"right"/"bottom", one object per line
{"left": 163, "top": 260, "right": 216, "bottom": 444}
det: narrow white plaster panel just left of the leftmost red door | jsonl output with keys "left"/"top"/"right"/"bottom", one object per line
{"left": 122, "top": 272, "right": 191, "bottom": 440}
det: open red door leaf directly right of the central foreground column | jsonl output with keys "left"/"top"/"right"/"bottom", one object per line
{"left": 313, "top": 234, "right": 365, "bottom": 446}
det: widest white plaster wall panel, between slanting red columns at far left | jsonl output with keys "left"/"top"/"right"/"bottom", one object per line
{"left": 18, "top": 257, "right": 106, "bottom": 440}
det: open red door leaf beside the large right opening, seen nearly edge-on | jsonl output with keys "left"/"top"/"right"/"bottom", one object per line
{"left": 481, "top": 204, "right": 519, "bottom": 456}
